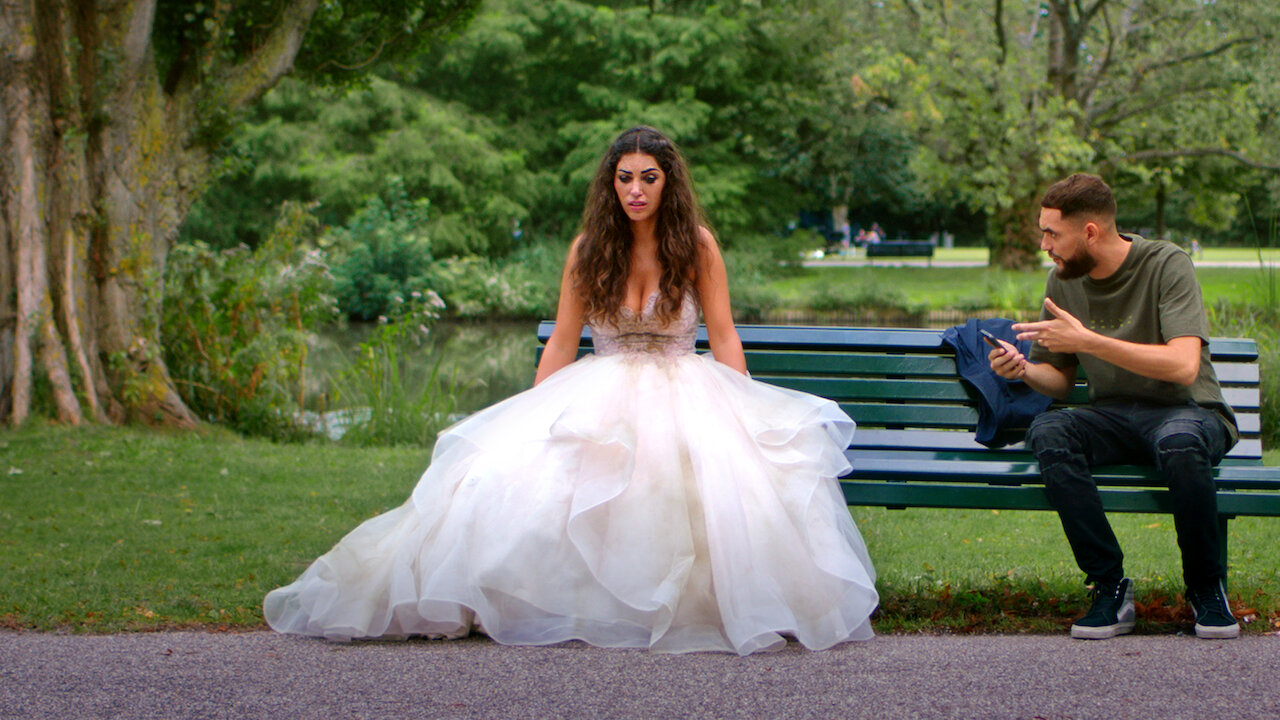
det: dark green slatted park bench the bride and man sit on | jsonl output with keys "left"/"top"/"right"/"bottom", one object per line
{"left": 538, "top": 322, "right": 1280, "bottom": 562}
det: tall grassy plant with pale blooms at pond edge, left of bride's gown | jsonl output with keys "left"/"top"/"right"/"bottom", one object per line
{"left": 334, "top": 291, "right": 460, "bottom": 447}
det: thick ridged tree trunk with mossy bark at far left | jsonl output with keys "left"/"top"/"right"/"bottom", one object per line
{"left": 0, "top": 0, "right": 316, "bottom": 427}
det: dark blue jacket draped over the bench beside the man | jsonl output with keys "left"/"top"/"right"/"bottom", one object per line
{"left": 942, "top": 318, "right": 1053, "bottom": 447}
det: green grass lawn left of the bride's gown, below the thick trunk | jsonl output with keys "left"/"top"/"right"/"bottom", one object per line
{"left": 0, "top": 427, "right": 428, "bottom": 632}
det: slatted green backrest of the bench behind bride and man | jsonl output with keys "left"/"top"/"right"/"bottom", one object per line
{"left": 538, "top": 322, "right": 1262, "bottom": 461}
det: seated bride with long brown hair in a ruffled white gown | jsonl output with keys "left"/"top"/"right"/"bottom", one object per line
{"left": 264, "top": 127, "right": 878, "bottom": 655}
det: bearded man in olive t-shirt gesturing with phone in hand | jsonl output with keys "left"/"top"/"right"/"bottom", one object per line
{"left": 989, "top": 174, "right": 1240, "bottom": 639}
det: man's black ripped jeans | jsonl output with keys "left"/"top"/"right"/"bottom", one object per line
{"left": 1027, "top": 402, "right": 1230, "bottom": 587}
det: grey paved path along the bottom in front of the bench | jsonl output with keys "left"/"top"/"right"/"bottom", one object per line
{"left": 0, "top": 632, "right": 1280, "bottom": 720}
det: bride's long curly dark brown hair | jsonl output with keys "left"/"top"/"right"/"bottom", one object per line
{"left": 572, "top": 126, "right": 705, "bottom": 323}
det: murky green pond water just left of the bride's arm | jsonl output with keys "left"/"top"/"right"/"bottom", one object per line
{"left": 307, "top": 320, "right": 538, "bottom": 414}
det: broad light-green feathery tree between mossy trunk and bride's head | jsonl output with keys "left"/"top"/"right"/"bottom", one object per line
{"left": 182, "top": 78, "right": 536, "bottom": 258}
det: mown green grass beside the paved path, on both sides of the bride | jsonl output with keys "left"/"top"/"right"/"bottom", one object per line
{"left": 0, "top": 423, "right": 1280, "bottom": 632}
